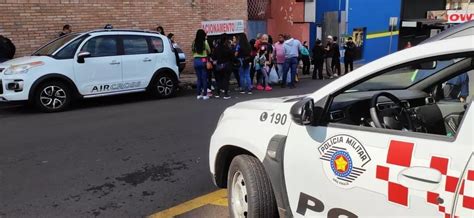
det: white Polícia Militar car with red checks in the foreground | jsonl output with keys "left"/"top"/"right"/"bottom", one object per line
{"left": 210, "top": 34, "right": 474, "bottom": 217}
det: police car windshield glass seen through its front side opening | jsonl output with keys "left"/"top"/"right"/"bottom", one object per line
{"left": 346, "top": 59, "right": 458, "bottom": 92}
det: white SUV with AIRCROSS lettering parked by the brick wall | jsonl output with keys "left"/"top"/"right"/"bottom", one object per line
{"left": 0, "top": 30, "right": 179, "bottom": 112}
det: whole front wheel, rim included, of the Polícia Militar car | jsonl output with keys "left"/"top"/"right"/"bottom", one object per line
{"left": 227, "top": 155, "right": 278, "bottom": 217}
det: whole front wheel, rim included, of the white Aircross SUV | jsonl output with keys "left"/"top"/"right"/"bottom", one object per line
{"left": 34, "top": 81, "right": 72, "bottom": 113}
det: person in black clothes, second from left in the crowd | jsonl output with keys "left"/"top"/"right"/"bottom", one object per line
{"left": 214, "top": 34, "right": 234, "bottom": 99}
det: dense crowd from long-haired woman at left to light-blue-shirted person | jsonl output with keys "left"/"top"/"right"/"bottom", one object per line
{"left": 192, "top": 29, "right": 309, "bottom": 100}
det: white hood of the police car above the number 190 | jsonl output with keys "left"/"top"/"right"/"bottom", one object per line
{"left": 232, "top": 95, "right": 307, "bottom": 110}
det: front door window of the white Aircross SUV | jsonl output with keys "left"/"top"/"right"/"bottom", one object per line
{"left": 81, "top": 36, "right": 117, "bottom": 57}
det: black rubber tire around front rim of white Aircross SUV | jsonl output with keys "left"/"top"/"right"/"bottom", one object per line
{"left": 33, "top": 81, "right": 72, "bottom": 113}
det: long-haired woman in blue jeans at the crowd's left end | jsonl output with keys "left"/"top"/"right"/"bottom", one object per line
{"left": 192, "top": 29, "right": 211, "bottom": 100}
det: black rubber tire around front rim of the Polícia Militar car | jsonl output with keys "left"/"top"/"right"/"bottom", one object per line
{"left": 227, "top": 155, "right": 278, "bottom": 217}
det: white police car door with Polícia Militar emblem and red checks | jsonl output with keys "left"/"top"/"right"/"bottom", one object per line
{"left": 284, "top": 103, "right": 474, "bottom": 217}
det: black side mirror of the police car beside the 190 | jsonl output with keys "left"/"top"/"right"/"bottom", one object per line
{"left": 290, "top": 98, "right": 314, "bottom": 126}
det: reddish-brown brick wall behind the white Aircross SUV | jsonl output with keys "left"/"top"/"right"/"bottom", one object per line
{"left": 0, "top": 0, "right": 247, "bottom": 71}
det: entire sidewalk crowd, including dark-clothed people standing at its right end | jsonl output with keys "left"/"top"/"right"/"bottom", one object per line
{"left": 192, "top": 29, "right": 356, "bottom": 100}
